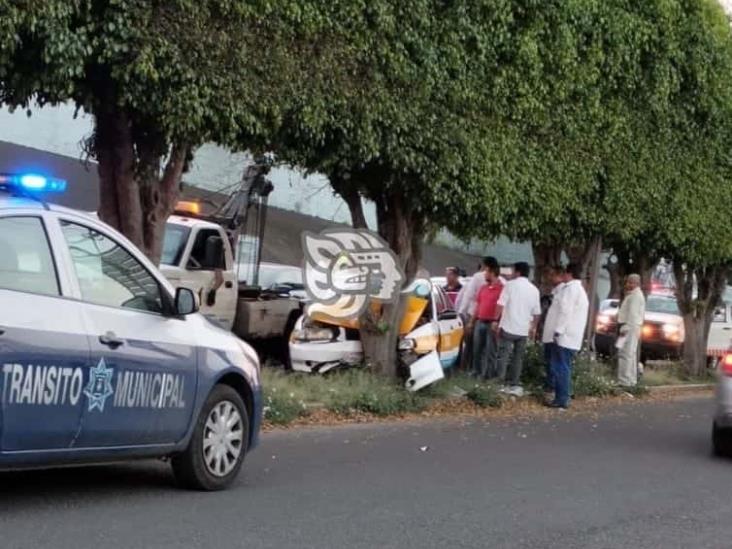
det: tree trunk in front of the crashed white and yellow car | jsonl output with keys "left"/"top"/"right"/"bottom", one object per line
{"left": 360, "top": 189, "right": 425, "bottom": 378}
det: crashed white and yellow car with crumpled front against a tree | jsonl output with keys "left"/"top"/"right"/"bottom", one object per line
{"left": 289, "top": 279, "right": 464, "bottom": 391}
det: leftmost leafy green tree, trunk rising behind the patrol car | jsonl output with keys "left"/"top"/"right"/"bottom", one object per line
{"left": 0, "top": 0, "right": 318, "bottom": 261}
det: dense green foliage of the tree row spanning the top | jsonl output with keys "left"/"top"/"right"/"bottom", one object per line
{"left": 0, "top": 0, "right": 732, "bottom": 376}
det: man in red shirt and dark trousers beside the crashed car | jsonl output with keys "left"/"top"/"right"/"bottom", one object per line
{"left": 473, "top": 258, "right": 503, "bottom": 379}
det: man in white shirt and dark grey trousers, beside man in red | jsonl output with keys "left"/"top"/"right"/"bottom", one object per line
{"left": 494, "top": 261, "right": 541, "bottom": 397}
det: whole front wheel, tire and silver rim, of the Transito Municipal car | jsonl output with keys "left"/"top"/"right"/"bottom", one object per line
{"left": 171, "top": 385, "right": 249, "bottom": 490}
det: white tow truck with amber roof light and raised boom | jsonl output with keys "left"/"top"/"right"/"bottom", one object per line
{"left": 160, "top": 163, "right": 302, "bottom": 341}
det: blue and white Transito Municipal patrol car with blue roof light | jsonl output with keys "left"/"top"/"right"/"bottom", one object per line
{"left": 0, "top": 174, "right": 262, "bottom": 490}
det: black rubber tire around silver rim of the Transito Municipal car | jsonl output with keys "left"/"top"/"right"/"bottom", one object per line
{"left": 171, "top": 385, "right": 249, "bottom": 491}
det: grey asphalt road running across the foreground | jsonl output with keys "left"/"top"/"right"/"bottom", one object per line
{"left": 0, "top": 399, "right": 732, "bottom": 549}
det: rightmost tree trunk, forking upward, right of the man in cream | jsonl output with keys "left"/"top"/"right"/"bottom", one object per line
{"left": 674, "top": 261, "right": 728, "bottom": 376}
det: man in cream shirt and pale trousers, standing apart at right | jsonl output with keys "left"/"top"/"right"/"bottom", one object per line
{"left": 618, "top": 274, "right": 646, "bottom": 387}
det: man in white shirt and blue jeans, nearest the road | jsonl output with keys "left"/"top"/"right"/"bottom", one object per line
{"left": 549, "top": 264, "right": 590, "bottom": 410}
